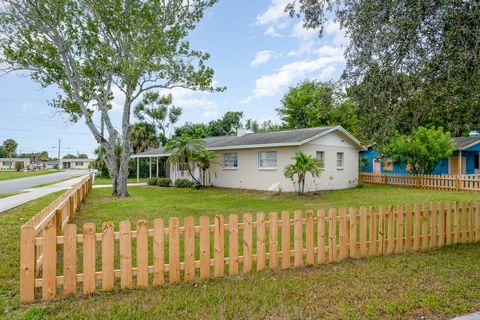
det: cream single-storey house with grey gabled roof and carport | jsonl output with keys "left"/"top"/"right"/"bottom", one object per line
{"left": 133, "top": 126, "right": 364, "bottom": 191}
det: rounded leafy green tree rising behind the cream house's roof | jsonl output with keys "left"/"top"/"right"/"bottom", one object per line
{"left": 277, "top": 80, "right": 358, "bottom": 134}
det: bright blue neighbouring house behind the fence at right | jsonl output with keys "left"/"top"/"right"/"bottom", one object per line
{"left": 359, "top": 131, "right": 480, "bottom": 175}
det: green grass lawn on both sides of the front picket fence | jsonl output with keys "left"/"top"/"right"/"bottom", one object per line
{"left": 0, "top": 185, "right": 480, "bottom": 319}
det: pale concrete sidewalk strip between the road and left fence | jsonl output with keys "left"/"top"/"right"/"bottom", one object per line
{"left": 0, "top": 175, "right": 86, "bottom": 212}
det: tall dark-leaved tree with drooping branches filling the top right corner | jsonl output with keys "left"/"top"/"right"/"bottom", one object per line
{"left": 286, "top": 0, "right": 480, "bottom": 144}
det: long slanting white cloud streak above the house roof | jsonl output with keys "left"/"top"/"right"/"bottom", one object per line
{"left": 241, "top": 48, "right": 344, "bottom": 103}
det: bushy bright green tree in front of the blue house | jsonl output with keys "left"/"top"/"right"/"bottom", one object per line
{"left": 380, "top": 127, "right": 455, "bottom": 174}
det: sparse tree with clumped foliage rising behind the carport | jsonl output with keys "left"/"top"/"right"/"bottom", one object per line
{"left": 133, "top": 92, "right": 182, "bottom": 144}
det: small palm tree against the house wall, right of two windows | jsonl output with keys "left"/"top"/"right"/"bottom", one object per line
{"left": 283, "top": 151, "right": 323, "bottom": 194}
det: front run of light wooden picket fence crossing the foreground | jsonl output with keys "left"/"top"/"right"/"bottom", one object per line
{"left": 20, "top": 201, "right": 480, "bottom": 302}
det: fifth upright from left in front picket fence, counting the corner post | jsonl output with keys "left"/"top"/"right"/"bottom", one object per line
{"left": 100, "top": 222, "right": 115, "bottom": 291}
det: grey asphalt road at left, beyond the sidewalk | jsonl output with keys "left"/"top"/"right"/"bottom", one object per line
{"left": 0, "top": 170, "right": 88, "bottom": 194}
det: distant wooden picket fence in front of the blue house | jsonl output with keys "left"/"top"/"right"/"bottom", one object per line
{"left": 360, "top": 173, "right": 480, "bottom": 191}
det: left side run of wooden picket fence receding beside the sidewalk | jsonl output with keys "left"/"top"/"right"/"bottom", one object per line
{"left": 20, "top": 176, "right": 92, "bottom": 301}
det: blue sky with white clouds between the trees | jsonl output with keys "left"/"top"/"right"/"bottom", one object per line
{"left": 0, "top": 0, "right": 348, "bottom": 157}
